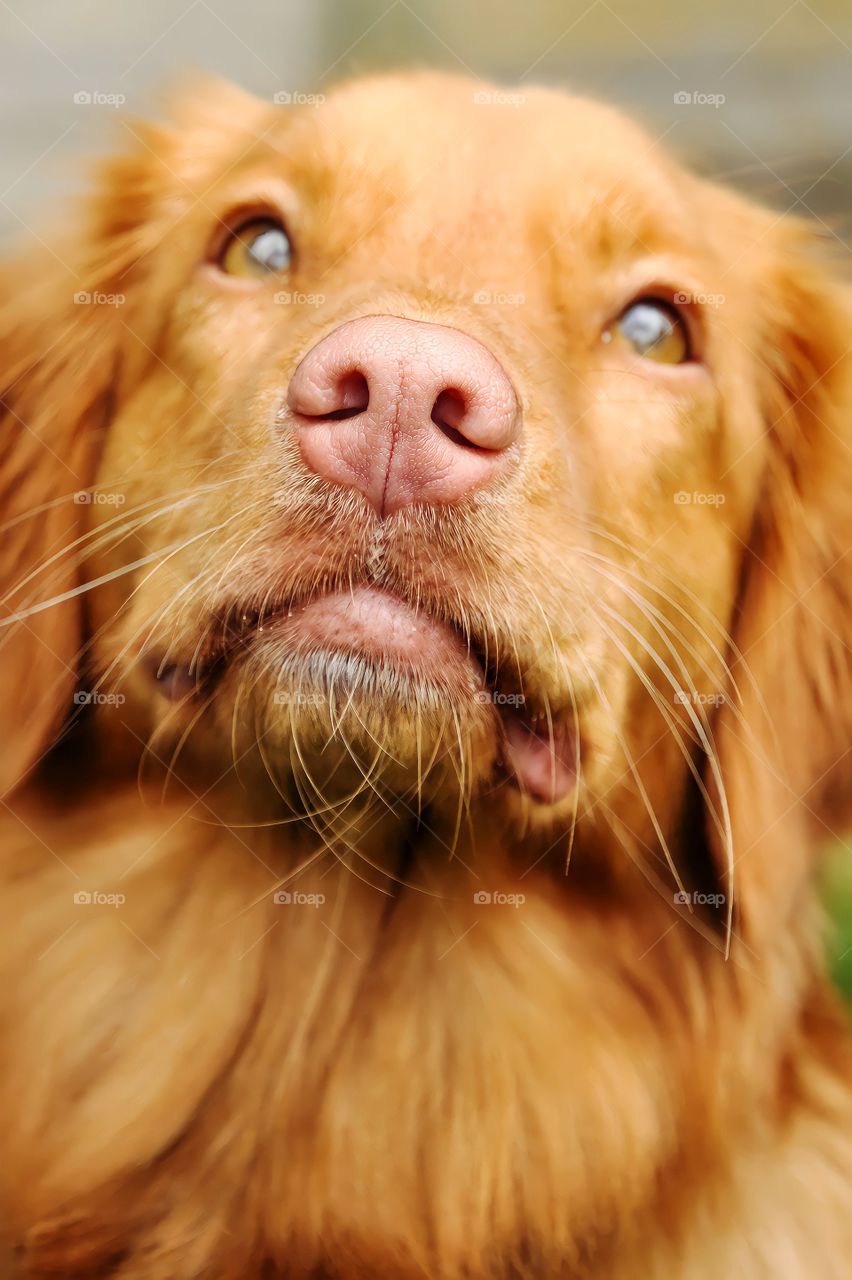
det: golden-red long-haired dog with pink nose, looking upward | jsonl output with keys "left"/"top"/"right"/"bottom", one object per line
{"left": 0, "top": 72, "right": 852, "bottom": 1280}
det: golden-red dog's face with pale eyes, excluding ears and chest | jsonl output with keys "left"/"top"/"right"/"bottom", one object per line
{"left": 1, "top": 77, "right": 847, "bottom": 931}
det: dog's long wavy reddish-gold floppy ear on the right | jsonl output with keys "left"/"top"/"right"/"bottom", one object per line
{"left": 710, "top": 224, "right": 852, "bottom": 943}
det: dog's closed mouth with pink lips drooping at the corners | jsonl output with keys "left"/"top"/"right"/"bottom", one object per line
{"left": 154, "top": 585, "right": 580, "bottom": 804}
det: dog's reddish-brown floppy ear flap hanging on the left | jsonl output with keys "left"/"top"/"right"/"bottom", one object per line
{"left": 0, "top": 122, "right": 161, "bottom": 796}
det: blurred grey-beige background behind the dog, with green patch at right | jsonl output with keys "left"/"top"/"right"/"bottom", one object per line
{"left": 0, "top": 0, "right": 852, "bottom": 977}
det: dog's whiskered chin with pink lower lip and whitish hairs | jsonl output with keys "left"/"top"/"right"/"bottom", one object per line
{"left": 194, "top": 588, "right": 576, "bottom": 813}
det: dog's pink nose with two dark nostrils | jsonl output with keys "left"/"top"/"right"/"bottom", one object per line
{"left": 287, "top": 316, "right": 521, "bottom": 516}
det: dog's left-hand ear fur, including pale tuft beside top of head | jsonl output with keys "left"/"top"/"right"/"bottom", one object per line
{"left": 0, "top": 82, "right": 272, "bottom": 795}
